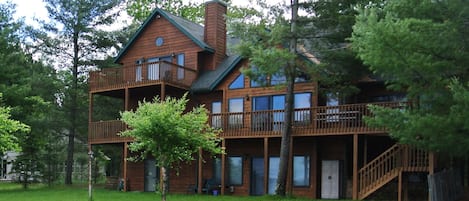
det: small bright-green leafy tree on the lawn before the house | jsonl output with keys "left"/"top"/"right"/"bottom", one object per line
{"left": 121, "top": 94, "right": 222, "bottom": 201}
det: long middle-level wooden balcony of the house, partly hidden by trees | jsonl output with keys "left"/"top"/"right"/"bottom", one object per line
{"left": 89, "top": 102, "right": 407, "bottom": 143}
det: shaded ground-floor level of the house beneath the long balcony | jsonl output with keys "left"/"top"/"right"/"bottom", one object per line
{"left": 93, "top": 135, "right": 425, "bottom": 199}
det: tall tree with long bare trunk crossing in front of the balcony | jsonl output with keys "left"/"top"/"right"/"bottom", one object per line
{"left": 231, "top": 0, "right": 311, "bottom": 196}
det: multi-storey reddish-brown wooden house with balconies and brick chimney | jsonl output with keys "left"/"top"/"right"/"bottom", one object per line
{"left": 88, "top": 0, "right": 433, "bottom": 200}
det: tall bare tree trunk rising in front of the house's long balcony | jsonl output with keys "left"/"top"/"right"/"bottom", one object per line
{"left": 275, "top": 0, "right": 298, "bottom": 196}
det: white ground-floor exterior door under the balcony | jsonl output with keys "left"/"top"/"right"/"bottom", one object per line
{"left": 321, "top": 160, "right": 339, "bottom": 199}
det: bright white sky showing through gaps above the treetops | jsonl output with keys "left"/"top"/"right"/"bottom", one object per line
{"left": 0, "top": 0, "right": 290, "bottom": 25}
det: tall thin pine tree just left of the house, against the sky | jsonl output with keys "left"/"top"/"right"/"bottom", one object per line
{"left": 37, "top": 0, "right": 122, "bottom": 184}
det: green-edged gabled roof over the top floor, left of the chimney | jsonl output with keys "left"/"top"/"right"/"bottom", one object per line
{"left": 114, "top": 8, "right": 215, "bottom": 63}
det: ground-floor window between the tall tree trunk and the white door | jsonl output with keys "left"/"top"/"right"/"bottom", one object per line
{"left": 293, "top": 156, "right": 310, "bottom": 186}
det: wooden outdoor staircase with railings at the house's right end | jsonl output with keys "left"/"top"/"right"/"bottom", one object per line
{"left": 358, "top": 144, "right": 429, "bottom": 200}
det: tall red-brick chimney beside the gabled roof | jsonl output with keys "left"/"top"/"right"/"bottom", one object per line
{"left": 204, "top": 0, "right": 227, "bottom": 70}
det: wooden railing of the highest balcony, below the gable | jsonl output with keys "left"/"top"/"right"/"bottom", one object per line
{"left": 89, "top": 61, "right": 197, "bottom": 91}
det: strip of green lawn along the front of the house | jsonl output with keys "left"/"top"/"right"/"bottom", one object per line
{"left": 0, "top": 183, "right": 348, "bottom": 201}
